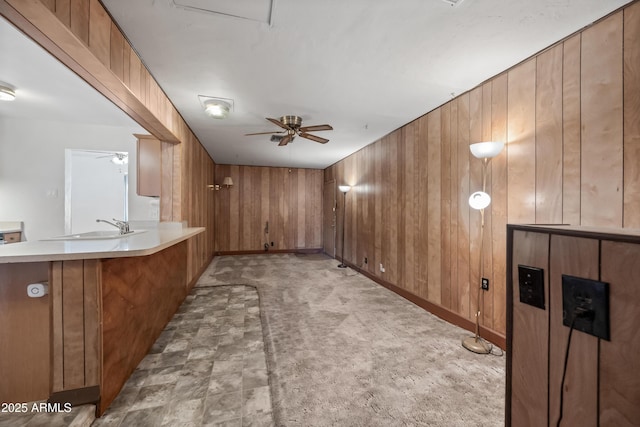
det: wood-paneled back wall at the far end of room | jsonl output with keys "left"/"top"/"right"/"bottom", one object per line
{"left": 216, "top": 165, "right": 323, "bottom": 253}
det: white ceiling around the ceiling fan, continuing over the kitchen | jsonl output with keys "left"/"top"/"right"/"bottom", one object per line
{"left": 0, "top": 0, "right": 629, "bottom": 168}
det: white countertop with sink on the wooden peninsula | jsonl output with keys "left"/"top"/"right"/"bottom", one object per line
{"left": 0, "top": 227, "right": 205, "bottom": 264}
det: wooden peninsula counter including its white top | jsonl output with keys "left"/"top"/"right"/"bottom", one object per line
{"left": 0, "top": 227, "right": 205, "bottom": 415}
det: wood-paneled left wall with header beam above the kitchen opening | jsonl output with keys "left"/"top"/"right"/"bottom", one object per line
{"left": 0, "top": 0, "right": 215, "bottom": 280}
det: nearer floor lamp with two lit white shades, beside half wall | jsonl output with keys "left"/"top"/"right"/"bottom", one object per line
{"left": 462, "top": 141, "right": 504, "bottom": 354}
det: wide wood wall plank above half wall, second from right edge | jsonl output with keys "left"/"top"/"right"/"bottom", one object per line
{"left": 580, "top": 13, "right": 633, "bottom": 227}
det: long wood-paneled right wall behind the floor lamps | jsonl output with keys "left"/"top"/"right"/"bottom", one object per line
{"left": 325, "top": 2, "right": 640, "bottom": 336}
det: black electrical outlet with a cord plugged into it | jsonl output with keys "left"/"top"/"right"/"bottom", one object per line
{"left": 562, "top": 274, "right": 609, "bottom": 341}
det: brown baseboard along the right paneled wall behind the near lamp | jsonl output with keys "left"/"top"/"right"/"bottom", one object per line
{"left": 344, "top": 261, "right": 507, "bottom": 350}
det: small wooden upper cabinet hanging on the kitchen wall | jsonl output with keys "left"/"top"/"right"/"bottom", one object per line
{"left": 135, "top": 135, "right": 162, "bottom": 197}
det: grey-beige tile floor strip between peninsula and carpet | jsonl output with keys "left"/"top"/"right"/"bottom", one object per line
{"left": 92, "top": 286, "right": 274, "bottom": 427}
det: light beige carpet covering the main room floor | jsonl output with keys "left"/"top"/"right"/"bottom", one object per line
{"left": 199, "top": 254, "right": 505, "bottom": 427}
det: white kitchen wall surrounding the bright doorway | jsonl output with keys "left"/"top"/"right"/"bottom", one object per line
{"left": 0, "top": 117, "right": 157, "bottom": 240}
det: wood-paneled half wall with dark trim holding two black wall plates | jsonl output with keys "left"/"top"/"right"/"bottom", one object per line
{"left": 506, "top": 225, "right": 640, "bottom": 427}
